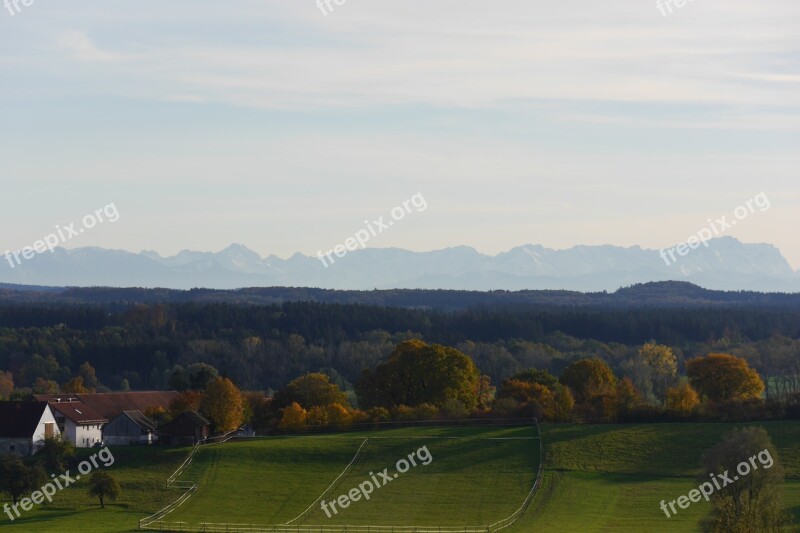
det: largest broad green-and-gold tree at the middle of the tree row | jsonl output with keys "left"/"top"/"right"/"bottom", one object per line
{"left": 356, "top": 339, "right": 480, "bottom": 410}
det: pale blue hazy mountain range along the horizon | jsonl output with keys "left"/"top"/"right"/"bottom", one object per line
{"left": 0, "top": 237, "right": 800, "bottom": 292}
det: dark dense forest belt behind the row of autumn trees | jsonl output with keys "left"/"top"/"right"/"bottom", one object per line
{"left": 0, "top": 294, "right": 800, "bottom": 402}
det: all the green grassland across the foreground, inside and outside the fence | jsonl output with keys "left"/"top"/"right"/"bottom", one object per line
{"left": 0, "top": 422, "right": 800, "bottom": 533}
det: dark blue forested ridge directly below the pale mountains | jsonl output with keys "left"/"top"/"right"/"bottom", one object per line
{"left": 0, "top": 281, "right": 800, "bottom": 310}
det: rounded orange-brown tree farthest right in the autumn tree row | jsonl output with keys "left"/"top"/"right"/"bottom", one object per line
{"left": 686, "top": 353, "right": 764, "bottom": 402}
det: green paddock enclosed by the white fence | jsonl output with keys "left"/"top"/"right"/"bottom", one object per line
{"left": 165, "top": 427, "right": 539, "bottom": 527}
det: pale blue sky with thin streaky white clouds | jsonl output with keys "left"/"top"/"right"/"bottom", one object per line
{"left": 0, "top": 0, "right": 800, "bottom": 269}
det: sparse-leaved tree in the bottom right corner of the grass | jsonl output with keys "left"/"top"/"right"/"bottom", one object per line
{"left": 699, "top": 427, "right": 791, "bottom": 533}
